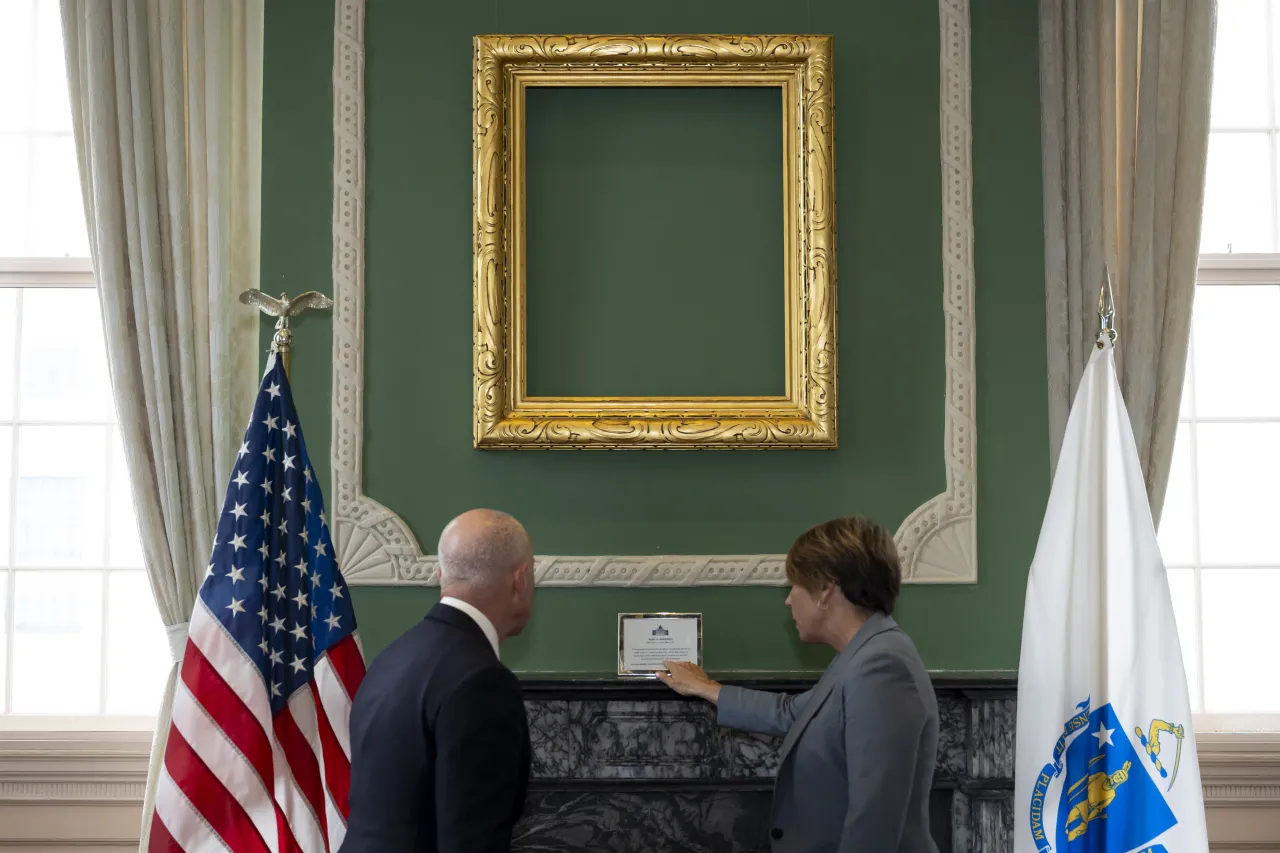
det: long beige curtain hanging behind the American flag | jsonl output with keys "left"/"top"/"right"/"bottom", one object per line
{"left": 61, "top": 0, "right": 262, "bottom": 850}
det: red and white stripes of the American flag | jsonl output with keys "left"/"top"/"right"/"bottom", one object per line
{"left": 148, "top": 599, "right": 365, "bottom": 853}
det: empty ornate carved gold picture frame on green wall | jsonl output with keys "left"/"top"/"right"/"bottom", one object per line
{"left": 472, "top": 36, "right": 836, "bottom": 450}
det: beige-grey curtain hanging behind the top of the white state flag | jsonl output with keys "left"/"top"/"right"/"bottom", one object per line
{"left": 1039, "top": 0, "right": 1216, "bottom": 521}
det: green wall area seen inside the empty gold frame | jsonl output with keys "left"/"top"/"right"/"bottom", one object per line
{"left": 525, "top": 87, "right": 786, "bottom": 397}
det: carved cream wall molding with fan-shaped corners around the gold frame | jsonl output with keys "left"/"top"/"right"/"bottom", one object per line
{"left": 330, "top": 0, "right": 978, "bottom": 587}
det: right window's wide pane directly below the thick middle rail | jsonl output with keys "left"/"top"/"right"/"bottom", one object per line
{"left": 1193, "top": 284, "right": 1280, "bottom": 418}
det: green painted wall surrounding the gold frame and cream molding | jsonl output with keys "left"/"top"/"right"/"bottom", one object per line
{"left": 262, "top": 0, "right": 1048, "bottom": 674}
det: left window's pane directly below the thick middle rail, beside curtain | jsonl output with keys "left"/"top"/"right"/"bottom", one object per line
{"left": 19, "top": 287, "right": 114, "bottom": 421}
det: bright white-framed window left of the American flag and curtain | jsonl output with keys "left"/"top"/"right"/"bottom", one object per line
{"left": 0, "top": 0, "right": 169, "bottom": 727}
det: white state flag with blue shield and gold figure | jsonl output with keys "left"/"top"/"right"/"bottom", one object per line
{"left": 1014, "top": 342, "right": 1208, "bottom": 853}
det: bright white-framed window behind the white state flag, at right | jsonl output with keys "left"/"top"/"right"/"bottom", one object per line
{"left": 1160, "top": 0, "right": 1280, "bottom": 729}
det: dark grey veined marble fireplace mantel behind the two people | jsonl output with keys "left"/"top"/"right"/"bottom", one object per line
{"left": 515, "top": 676, "right": 1016, "bottom": 853}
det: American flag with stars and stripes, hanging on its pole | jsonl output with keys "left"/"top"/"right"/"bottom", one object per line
{"left": 148, "top": 355, "right": 365, "bottom": 853}
